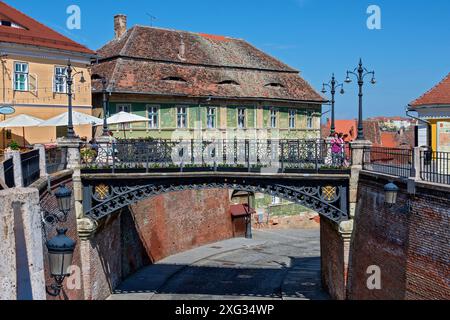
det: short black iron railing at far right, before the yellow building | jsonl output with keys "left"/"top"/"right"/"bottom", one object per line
{"left": 420, "top": 151, "right": 450, "bottom": 184}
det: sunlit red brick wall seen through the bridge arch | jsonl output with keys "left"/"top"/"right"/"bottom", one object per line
{"left": 127, "top": 189, "right": 233, "bottom": 262}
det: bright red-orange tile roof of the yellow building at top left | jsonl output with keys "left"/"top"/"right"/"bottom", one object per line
{"left": 0, "top": 1, "right": 94, "bottom": 54}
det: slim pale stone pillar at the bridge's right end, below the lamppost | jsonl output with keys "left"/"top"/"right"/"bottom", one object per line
{"left": 349, "top": 140, "right": 372, "bottom": 219}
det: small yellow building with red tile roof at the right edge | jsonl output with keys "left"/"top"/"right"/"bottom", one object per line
{"left": 409, "top": 73, "right": 450, "bottom": 152}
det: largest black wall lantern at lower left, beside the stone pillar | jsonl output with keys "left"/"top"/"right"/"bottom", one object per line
{"left": 46, "top": 229, "right": 76, "bottom": 297}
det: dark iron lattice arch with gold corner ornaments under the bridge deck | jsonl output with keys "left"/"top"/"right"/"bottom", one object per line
{"left": 83, "top": 174, "right": 349, "bottom": 224}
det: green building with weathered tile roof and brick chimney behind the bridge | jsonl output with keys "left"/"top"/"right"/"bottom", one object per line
{"left": 93, "top": 16, "right": 324, "bottom": 139}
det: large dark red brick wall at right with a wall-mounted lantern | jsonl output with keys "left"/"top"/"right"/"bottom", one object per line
{"left": 348, "top": 173, "right": 450, "bottom": 300}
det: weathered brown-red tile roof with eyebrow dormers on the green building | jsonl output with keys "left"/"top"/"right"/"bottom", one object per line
{"left": 92, "top": 26, "right": 325, "bottom": 103}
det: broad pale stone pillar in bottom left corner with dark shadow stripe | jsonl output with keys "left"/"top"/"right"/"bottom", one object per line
{"left": 0, "top": 188, "right": 46, "bottom": 300}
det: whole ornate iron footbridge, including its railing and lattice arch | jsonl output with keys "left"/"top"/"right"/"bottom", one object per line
{"left": 82, "top": 140, "right": 349, "bottom": 223}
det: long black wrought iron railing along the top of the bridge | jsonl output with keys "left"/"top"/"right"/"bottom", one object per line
{"left": 81, "top": 140, "right": 351, "bottom": 173}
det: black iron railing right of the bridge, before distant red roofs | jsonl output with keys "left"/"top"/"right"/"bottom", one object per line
{"left": 363, "top": 147, "right": 414, "bottom": 178}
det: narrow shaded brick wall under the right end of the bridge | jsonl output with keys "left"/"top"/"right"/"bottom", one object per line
{"left": 320, "top": 218, "right": 349, "bottom": 300}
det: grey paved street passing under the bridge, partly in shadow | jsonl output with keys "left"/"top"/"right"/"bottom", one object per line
{"left": 109, "top": 230, "right": 329, "bottom": 300}
